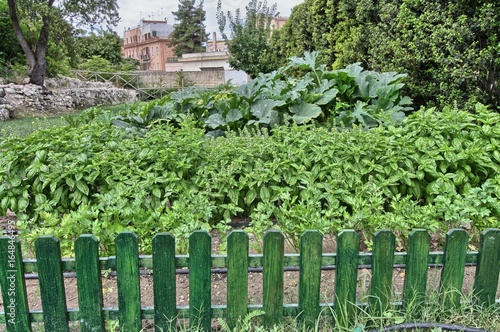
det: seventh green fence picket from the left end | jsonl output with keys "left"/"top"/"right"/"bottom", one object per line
{"left": 227, "top": 231, "right": 249, "bottom": 330}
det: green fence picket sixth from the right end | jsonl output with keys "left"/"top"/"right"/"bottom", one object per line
{"left": 299, "top": 231, "right": 323, "bottom": 329}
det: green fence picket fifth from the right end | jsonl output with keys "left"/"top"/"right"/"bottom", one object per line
{"left": 334, "top": 230, "right": 359, "bottom": 326}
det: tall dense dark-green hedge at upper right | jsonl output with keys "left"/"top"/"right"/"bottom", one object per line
{"left": 271, "top": 0, "right": 500, "bottom": 107}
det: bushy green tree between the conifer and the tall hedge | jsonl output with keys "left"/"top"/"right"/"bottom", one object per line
{"left": 217, "top": 0, "right": 278, "bottom": 78}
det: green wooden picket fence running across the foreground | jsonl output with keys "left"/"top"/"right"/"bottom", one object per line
{"left": 0, "top": 229, "right": 500, "bottom": 332}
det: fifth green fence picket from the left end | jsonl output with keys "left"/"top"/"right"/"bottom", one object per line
{"left": 153, "top": 233, "right": 177, "bottom": 332}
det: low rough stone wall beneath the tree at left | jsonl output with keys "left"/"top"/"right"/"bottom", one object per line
{"left": 0, "top": 77, "right": 137, "bottom": 121}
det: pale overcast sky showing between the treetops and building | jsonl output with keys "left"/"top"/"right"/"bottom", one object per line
{"left": 116, "top": 0, "right": 304, "bottom": 38}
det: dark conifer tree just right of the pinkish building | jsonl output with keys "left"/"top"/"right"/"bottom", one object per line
{"left": 170, "top": 0, "right": 208, "bottom": 56}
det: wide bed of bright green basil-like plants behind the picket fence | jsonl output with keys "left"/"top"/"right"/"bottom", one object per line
{"left": 0, "top": 101, "right": 500, "bottom": 252}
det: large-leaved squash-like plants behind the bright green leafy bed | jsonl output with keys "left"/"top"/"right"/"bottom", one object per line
{"left": 115, "top": 52, "right": 411, "bottom": 136}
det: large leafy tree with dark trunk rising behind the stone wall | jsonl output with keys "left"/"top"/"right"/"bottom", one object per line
{"left": 7, "top": 0, "right": 120, "bottom": 86}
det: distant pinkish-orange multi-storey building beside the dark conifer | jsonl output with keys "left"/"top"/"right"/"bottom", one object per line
{"left": 122, "top": 20, "right": 177, "bottom": 71}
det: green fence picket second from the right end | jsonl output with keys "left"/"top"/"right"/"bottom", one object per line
{"left": 440, "top": 229, "right": 469, "bottom": 309}
